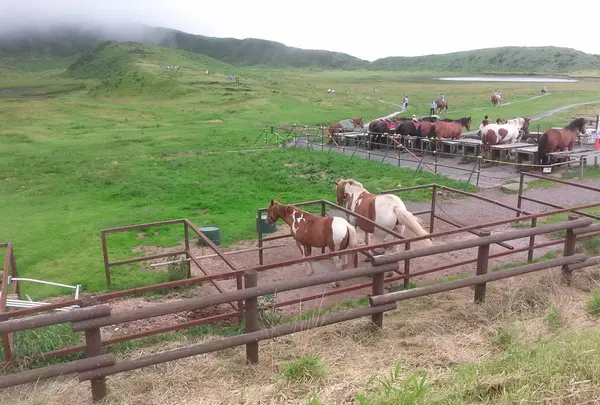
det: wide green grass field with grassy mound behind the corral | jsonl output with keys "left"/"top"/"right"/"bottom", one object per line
{"left": 0, "top": 44, "right": 600, "bottom": 299}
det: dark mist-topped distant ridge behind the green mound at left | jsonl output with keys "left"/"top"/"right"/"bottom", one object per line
{"left": 0, "top": 25, "right": 369, "bottom": 69}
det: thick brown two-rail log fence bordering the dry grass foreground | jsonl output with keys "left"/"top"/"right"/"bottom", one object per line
{"left": 0, "top": 217, "right": 598, "bottom": 401}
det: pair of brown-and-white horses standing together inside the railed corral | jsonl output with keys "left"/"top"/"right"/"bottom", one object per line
{"left": 267, "top": 179, "right": 432, "bottom": 286}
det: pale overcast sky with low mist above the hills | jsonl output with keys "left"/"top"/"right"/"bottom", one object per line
{"left": 0, "top": 0, "right": 600, "bottom": 60}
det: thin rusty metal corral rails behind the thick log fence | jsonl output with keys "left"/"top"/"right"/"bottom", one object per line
{"left": 4, "top": 178, "right": 600, "bottom": 357}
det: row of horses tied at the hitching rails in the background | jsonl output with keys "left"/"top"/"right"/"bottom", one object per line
{"left": 328, "top": 116, "right": 586, "bottom": 165}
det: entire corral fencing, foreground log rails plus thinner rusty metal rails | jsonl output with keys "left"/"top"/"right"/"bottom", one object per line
{"left": 0, "top": 173, "right": 600, "bottom": 399}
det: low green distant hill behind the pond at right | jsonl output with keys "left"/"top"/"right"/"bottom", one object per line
{"left": 369, "top": 47, "right": 600, "bottom": 74}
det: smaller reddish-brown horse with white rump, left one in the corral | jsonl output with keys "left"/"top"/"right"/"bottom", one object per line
{"left": 267, "top": 199, "right": 358, "bottom": 276}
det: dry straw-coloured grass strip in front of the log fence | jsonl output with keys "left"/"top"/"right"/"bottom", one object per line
{"left": 0, "top": 268, "right": 600, "bottom": 405}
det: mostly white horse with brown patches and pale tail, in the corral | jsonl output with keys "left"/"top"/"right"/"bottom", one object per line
{"left": 335, "top": 179, "right": 432, "bottom": 256}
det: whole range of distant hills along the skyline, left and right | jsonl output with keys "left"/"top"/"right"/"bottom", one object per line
{"left": 0, "top": 24, "right": 600, "bottom": 74}
